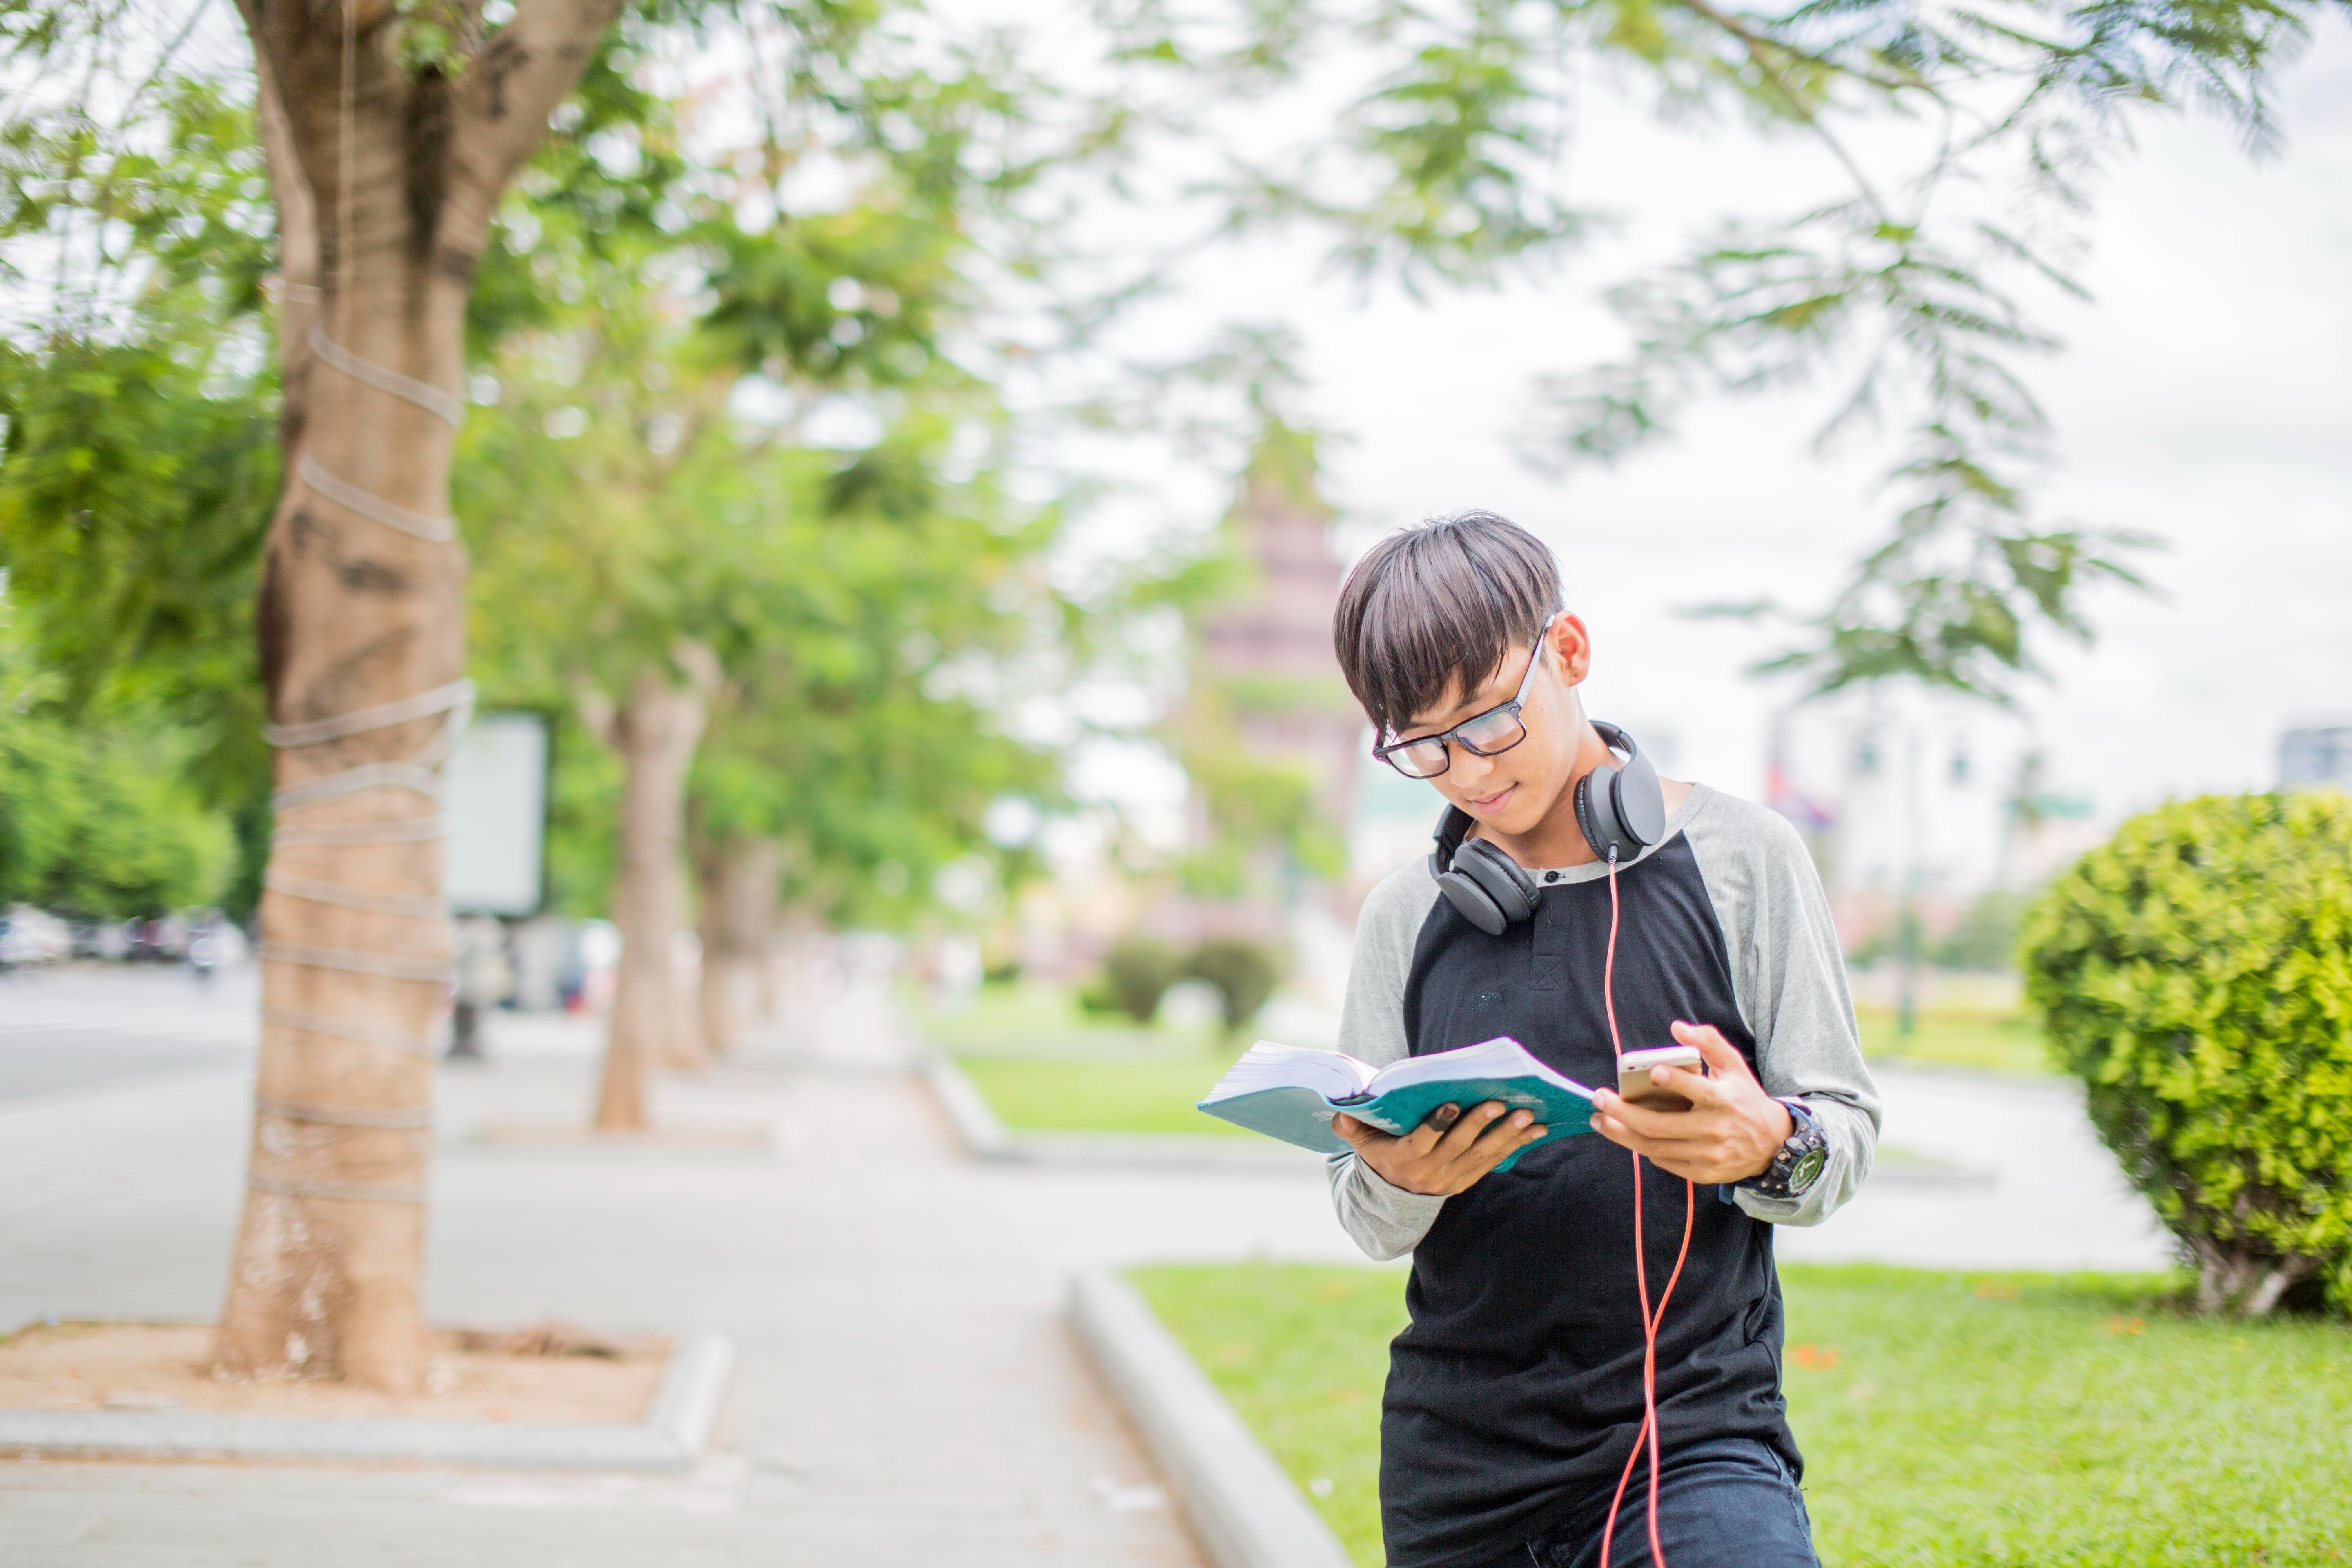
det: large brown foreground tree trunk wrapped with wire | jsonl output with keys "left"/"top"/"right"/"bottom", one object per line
{"left": 214, "top": 0, "right": 619, "bottom": 1392}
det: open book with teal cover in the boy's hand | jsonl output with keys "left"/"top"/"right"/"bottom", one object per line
{"left": 1200, "top": 1037, "right": 1592, "bottom": 1171}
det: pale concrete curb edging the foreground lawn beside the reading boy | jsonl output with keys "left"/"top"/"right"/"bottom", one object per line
{"left": 1070, "top": 1274, "right": 1352, "bottom": 1568}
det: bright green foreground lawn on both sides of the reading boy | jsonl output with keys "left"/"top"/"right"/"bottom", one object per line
{"left": 1134, "top": 1265, "right": 2352, "bottom": 1568}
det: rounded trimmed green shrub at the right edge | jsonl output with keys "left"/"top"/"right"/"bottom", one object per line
{"left": 2023, "top": 792, "right": 2352, "bottom": 1314}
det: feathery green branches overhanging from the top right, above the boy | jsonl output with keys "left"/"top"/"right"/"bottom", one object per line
{"left": 1117, "top": 0, "right": 2340, "bottom": 696}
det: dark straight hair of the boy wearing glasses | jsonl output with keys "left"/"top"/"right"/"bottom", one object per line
{"left": 1331, "top": 512, "right": 1559, "bottom": 736}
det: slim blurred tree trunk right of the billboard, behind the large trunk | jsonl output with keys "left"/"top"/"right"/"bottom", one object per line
{"left": 595, "top": 646, "right": 717, "bottom": 1131}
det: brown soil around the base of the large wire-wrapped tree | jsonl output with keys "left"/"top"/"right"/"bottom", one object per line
{"left": 0, "top": 1321, "right": 670, "bottom": 1425}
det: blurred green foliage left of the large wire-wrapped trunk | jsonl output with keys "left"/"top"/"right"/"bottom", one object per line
{"left": 0, "top": 78, "right": 278, "bottom": 912}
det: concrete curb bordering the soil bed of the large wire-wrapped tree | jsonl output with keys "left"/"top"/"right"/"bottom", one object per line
{"left": 0, "top": 1333, "right": 734, "bottom": 1469}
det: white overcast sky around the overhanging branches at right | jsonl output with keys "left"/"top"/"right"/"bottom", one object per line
{"left": 1049, "top": 26, "right": 2352, "bottom": 851}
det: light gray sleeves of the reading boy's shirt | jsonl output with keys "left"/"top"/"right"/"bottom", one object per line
{"left": 1329, "top": 785, "right": 1879, "bottom": 1260}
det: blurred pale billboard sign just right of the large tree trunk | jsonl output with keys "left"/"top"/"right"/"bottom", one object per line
{"left": 447, "top": 712, "right": 553, "bottom": 915}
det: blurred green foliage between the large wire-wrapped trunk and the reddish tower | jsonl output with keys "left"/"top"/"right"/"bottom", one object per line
{"left": 456, "top": 40, "right": 1068, "bottom": 924}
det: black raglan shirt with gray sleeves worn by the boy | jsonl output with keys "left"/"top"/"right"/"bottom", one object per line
{"left": 1331, "top": 785, "right": 1879, "bottom": 1568}
